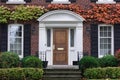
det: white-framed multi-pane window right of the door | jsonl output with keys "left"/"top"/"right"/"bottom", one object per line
{"left": 98, "top": 25, "right": 113, "bottom": 57}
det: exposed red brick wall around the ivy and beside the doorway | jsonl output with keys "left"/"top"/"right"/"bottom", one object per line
{"left": 0, "top": 0, "right": 91, "bottom": 55}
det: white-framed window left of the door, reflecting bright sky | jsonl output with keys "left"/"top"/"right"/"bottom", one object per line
{"left": 8, "top": 24, "right": 23, "bottom": 58}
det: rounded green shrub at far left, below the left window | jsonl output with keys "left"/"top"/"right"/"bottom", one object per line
{"left": 0, "top": 52, "right": 19, "bottom": 68}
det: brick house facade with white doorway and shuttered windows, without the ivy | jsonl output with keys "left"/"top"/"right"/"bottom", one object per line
{"left": 0, "top": 0, "right": 120, "bottom": 65}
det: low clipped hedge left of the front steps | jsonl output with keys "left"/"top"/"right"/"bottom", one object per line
{"left": 0, "top": 68, "right": 43, "bottom": 80}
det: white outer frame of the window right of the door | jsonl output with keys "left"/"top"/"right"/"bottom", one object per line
{"left": 98, "top": 24, "right": 114, "bottom": 58}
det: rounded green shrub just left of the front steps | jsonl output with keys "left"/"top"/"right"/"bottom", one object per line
{"left": 22, "top": 56, "right": 42, "bottom": 68}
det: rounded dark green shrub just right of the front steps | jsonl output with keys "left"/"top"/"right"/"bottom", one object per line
{"left": 79, "top": 56, "right": 99, "bottom": 71}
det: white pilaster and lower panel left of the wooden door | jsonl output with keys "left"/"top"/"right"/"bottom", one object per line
{"left": 39, "top": 23, "right": 52, "bottom": 65}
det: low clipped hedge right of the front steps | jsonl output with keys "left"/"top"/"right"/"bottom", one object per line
{"left": 84, "top": 67, "right": 120, "bottom": 79}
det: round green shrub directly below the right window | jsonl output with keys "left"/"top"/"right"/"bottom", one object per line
{"left": 99, "top": 55, "right": 118, "bottom": 67}
